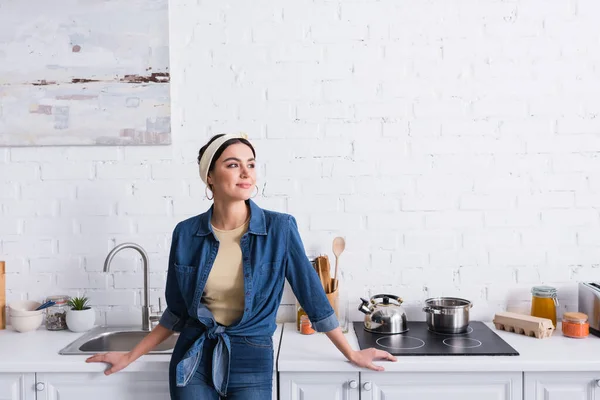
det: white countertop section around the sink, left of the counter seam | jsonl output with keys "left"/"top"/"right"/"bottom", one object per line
{"left": 0, "top": 324, "right": 282, "bottom": 373}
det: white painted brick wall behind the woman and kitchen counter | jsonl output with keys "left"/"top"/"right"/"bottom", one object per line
{"left": 0, "top": 0, "right": 600, "bottom": 323}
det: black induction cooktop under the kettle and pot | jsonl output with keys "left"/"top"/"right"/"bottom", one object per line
{"left": 354, "top": 321, "right": 519, "bottom": 356}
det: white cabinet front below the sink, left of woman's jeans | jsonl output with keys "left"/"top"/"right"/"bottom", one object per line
{"left": 35, "top": 371, "right": 170, "bottom": 400}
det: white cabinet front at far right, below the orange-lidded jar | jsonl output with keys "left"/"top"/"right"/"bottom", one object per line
{"left": 524, "top": 372, "right": 600, "bottom": 400}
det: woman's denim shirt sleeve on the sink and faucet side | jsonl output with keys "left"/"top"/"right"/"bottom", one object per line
{"left": 159, "top": 227, "right": 189, "bottom": 332}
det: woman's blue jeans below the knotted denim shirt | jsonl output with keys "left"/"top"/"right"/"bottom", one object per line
{"left": 169, "top": 336, "right": 273, "bottom": 400}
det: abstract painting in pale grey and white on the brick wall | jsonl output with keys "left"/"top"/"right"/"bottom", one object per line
{"left": 0, "top": 0, "right": 171, "bottom": 146}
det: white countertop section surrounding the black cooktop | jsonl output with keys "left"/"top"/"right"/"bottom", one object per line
{"left": 278, "top": 321, "right": 600, "bottom": 372}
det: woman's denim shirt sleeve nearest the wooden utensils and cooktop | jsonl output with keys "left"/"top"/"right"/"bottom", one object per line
{"left": 285, "top": 215, "right": 339, "bottom": 332}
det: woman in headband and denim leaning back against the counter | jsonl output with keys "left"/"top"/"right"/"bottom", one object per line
{"left": 87, "top": 134, "right": 396, "bottom": 400}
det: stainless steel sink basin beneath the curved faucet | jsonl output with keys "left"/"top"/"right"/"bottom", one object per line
{"left": 58, "top": 326, "right": 179, "bottom": 355}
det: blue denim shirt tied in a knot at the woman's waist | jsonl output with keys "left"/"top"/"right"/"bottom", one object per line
{"left": 160, "top": 200, "right": 338, "bottom": 395}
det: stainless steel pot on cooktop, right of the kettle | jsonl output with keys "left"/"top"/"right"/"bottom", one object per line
{"left": 423, "top": 297, "right": 473, "bottom": 333}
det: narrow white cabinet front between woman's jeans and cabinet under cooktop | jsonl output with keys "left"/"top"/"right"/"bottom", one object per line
{"left": 279, "top": 372, "right": 360, "bottom": 400}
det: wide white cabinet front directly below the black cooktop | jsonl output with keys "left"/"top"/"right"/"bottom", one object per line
{"left": 360, "top": 372, "right": 524, "bottom": 400}
